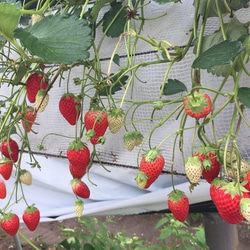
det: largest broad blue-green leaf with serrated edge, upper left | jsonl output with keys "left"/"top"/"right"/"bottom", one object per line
{"left": 15, "top": 14, "right": 92, "bottom": 64}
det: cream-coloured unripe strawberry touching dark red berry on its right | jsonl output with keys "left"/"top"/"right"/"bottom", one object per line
{"left": 185, "top": 156, "right": 202, "bottom": 184}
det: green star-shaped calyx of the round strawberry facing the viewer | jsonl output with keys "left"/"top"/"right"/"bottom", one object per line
{"left": 185, "top": 91, "right": 210, "bottom": 114}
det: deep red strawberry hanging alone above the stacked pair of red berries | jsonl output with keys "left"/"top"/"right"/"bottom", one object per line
{"left": 59, "top": 93, "right": 81, "bottom": 125}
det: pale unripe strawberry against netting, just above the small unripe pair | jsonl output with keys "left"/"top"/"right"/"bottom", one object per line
{"left": 108, "top": 108, "right": 125, "bottom": 134}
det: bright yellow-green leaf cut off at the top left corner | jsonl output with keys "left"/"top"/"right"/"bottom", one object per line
{"left": 0, "top": 3, "right": 21, "bottom": 40}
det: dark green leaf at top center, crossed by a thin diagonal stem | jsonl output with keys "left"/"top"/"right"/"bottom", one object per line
{"left": 102, "top": 2, "right": 127, "bottom": 37}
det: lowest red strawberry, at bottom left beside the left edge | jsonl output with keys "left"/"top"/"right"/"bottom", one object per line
{"left": 1, "top": 213, "right": 19, "bottom": 236}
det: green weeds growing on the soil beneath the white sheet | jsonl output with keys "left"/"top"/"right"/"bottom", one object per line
{"left": 56, "top": 214, "right": 208, "bottom": 250}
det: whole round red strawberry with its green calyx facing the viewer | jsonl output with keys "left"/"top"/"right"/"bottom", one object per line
{"left": 184, "top": 91, "right": 212, "bottom": 119}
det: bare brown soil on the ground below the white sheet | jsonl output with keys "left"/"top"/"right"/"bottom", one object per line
{"left": 0, "top": 213, "right": 250, "bottom": 250}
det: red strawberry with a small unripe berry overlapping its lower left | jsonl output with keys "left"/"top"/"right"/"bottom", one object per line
{"left": 140, "top": 149, "right": 165, "bottom": 189}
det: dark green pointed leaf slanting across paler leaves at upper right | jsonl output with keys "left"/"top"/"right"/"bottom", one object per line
{"left": 192, "top": 40, "right": 243, "bottom": 69}
